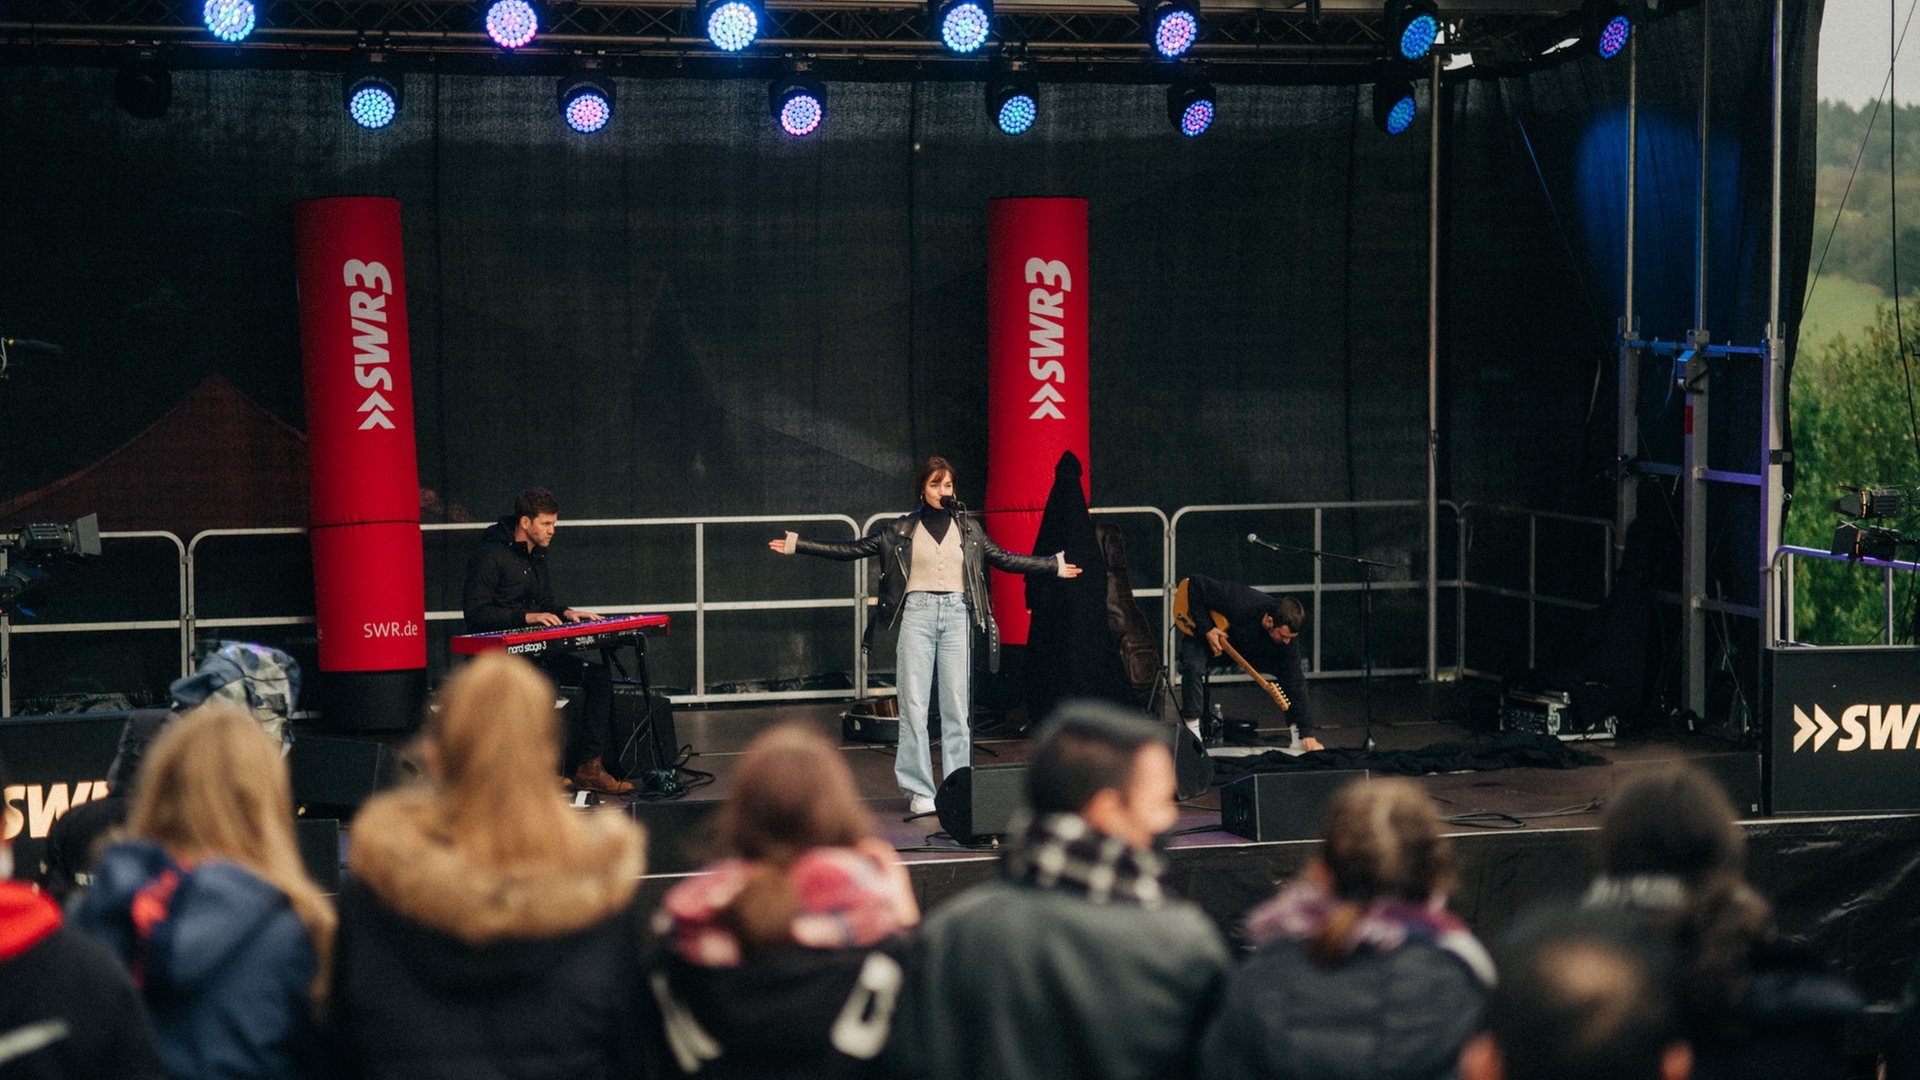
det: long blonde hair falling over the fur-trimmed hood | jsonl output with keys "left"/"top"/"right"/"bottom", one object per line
{"left": 428, "top": 653, "right": 602, "bottom": 867}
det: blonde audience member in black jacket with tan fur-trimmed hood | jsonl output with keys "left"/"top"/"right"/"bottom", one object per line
{"left": 328, "top": 655, "right": 657, "bottom": 1080}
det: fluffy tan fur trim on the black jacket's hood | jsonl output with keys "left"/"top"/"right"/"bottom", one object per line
{"left": 351, "top": 790, "right": 645, "bottom": 945}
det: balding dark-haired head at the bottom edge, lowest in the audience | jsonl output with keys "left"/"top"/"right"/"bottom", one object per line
{"left": 1459, "top": 909, "right": 1693, "bottom": 1080}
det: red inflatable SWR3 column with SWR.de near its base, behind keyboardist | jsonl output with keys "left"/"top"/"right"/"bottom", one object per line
{"left": 294, "top": 198, "right": 426, "bottom": 728}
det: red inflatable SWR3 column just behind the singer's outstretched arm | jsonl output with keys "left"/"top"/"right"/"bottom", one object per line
{"left": 987, "top": 198, "right": 1092, "bottom": 646}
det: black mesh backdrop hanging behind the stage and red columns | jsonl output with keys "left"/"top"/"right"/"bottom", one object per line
{"left": 0, "top": 0, "right": 1820, "bottom": 687}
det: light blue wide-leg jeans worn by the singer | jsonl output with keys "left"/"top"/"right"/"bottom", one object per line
{"left": 893, "top": 592, "right": 973, "bottom": 799}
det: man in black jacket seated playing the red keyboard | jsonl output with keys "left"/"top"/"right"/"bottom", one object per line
{"left": 463, "top": 488, "right": 634, "bottom": 796}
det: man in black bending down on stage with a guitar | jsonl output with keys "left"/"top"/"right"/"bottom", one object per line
{"left": 1179, "top": 575, "right": 1327, "bottom": 749}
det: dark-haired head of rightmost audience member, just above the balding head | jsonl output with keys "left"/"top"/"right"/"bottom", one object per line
{"left": 1599, "top": 765, "right": 1747, "bottom": 886}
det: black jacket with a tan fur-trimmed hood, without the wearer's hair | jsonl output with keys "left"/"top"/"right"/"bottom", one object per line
{"left": 328, "top": 780, "right": 657, "bottom": 1080}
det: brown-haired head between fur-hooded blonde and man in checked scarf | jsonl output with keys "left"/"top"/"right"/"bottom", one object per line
{"left": 718, "top": 723, "right": 874, "bottom": 865}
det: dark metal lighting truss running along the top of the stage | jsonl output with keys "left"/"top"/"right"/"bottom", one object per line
{"left": 0, "top": 0, "right": 1574, "bottom": 83}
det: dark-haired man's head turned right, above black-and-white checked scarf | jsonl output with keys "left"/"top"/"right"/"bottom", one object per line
{"left": 1027, "top": 701, "right": 1179, "bottom": 849}
